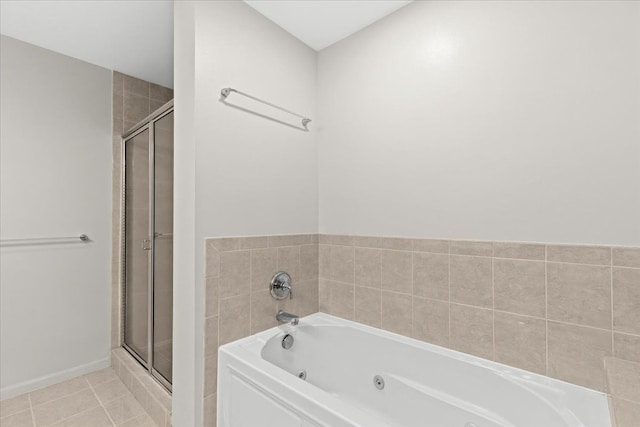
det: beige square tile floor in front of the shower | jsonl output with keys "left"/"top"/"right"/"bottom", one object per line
{"left": 0, "top": 368, "right": 157, "bottom": 427}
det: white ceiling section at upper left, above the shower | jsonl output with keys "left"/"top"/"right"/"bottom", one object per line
{"left": 0, "top": 0, "right": 173, "bottom": 87}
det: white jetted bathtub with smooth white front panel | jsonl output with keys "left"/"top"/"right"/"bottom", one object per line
{"left": 218, "top": 313, "right": 611, "bottom": 427}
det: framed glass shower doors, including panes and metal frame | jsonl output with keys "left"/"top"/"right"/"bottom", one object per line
{"left": 122, "top": 101, "right": 173, "bottom": 390}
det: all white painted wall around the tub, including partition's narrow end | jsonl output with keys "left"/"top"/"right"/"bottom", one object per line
{"left": 173, "top": 1, "right": 640, "bottom": 426}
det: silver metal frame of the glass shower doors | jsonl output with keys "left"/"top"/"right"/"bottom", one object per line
{"left": 120, "top": 100, "right": 174, "bottom": 392}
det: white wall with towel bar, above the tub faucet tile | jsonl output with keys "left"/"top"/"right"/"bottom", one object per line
{"left": 195, "top": 1, "right": 318, "bottom": 237}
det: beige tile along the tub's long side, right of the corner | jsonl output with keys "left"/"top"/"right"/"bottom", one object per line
{"left": 319, "top": 235, "right": 640, "bottom": 390}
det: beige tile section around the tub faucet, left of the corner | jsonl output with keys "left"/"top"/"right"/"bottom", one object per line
{"left": 203, "top": 234, "right": 318, "bottom": 427}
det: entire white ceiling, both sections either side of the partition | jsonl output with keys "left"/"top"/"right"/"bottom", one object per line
{"left": 0, "top": 0, "right": 411, "bottom": 87}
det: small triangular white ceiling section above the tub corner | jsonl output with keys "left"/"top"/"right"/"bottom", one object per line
{"left": 244, "top": 0, "right": 412, "bottom": 50}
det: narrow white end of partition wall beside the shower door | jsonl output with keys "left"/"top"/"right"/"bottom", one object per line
{"left": 171, "top": 1, "right": 198, "bottom": 426}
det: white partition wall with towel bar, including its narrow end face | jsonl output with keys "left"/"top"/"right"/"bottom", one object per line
{"left": 173, "top": 1, "right": 318, "bottom": 426}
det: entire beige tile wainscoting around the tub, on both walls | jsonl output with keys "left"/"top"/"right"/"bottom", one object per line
{"left": 204, "top": 234, "right": 640, "bottom": 426}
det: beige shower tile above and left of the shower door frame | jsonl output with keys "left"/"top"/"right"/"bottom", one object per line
{"left": 111, "top": 71, "right": 173, "bottom": 348}
